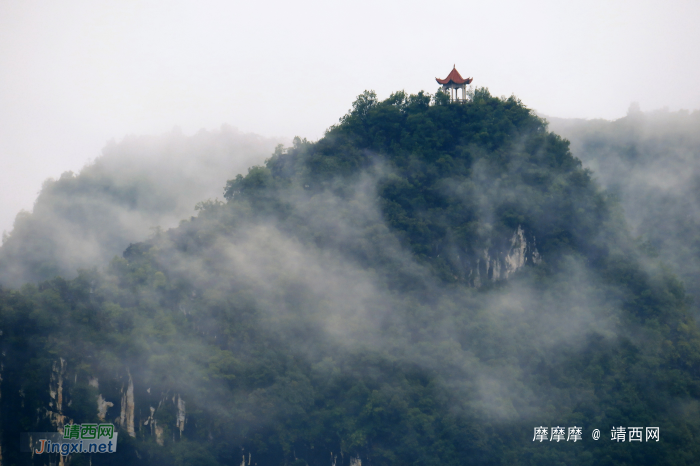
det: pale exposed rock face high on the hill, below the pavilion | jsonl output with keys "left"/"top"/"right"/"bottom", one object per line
{"left": 466, "top": 225, "right": 542, "bottom": 288}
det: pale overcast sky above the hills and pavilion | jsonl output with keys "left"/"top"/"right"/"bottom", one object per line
{"left": 0, "top": 0, "right": 700, "bottom": 235}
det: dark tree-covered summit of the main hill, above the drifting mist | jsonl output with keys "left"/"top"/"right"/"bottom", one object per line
{"left": 225, "top": 89, "right": 617, "bottom": 284}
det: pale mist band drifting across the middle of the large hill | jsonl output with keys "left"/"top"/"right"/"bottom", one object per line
{"left": 137, "top": 165, "right": 628, "bottom": 422}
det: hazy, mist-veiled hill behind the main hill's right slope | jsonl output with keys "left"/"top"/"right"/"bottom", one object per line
{"left": 550, "top": 109, "right": 700, "bottom": 317}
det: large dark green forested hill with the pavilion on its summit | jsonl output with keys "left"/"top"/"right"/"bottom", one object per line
{"left": 0, "top": 89, "right": 700, "bottom": 466}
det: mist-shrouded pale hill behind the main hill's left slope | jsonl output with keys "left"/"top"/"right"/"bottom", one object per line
{"left": 0, "top": 125, "right": 283, "bottom": 286}
